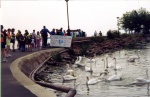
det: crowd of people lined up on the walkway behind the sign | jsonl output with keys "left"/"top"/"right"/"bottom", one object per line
{"left": 1, "top": 25, "right": 86, "bottom": 62}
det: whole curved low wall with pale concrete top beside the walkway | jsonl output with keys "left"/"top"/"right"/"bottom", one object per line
{"left": 10, "top": 48, "right": 64, "bottom": 97}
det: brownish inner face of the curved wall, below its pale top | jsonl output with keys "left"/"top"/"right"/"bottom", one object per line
{"left": 18, "top": 48, "right": 64, "bottom": 77}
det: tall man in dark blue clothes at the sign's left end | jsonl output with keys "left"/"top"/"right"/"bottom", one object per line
{"left": 40, "top": 26, "right": 50, "bottom": 48}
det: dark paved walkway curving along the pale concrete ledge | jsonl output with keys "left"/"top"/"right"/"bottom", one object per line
{"left": 1, "top": 49, "right": 55, "bottom": 97}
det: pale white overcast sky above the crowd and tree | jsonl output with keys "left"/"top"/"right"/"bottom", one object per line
{"left": 0, "top": 0, "right": 150, "bottom": 36}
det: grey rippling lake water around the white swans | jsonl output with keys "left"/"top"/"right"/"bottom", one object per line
{"left": 49, "top": 43, "right": 150, "bottom": 97}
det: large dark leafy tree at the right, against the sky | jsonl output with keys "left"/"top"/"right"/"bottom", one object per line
{"left": 120, "top": 8, "right": 150, "bottom": 34}
